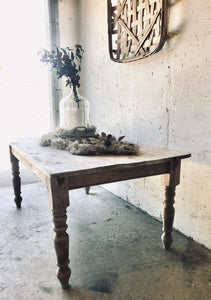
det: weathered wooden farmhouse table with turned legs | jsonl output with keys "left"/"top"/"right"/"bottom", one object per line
{"left": 9, "top": 138, "right": 191, "bottom": 288}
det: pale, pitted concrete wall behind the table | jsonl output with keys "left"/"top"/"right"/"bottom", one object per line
{"left": 60, "top": 0, "right": 211, "bottom": 248}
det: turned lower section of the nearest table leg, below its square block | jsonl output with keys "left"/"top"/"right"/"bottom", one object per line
{"left": 52, "top": 208, "right": 71, "bottom": 289}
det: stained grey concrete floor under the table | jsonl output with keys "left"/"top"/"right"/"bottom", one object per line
{"left": 0, "top": 183, "right": 211, "bottom": 300}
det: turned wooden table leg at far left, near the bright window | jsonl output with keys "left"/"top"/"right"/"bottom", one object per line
{"left": 10, "top": 148, "right": 22, "bottom": 208}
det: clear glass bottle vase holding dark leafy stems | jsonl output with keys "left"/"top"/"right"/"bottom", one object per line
{"left": 59, "top": 87, "right": 89, "bottom": 130}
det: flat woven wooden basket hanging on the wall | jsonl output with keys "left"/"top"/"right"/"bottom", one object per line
{"left": 107, "top": 0, "right": 167, "bottom": 62}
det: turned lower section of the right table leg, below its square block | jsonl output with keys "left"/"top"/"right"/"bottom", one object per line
{"left": 161, "top": 186, "right": 175, "bottom": 250}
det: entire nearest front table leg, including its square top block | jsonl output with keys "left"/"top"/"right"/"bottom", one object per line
{"left": 47, "top": 179, "right": 71, "bottom": 289}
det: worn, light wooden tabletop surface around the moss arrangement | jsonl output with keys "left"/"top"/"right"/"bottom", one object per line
{"left": 10, "top": 138, "right": 191, "bottom": 188}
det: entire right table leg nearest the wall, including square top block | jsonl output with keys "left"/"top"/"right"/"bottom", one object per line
{"left": 161, "top": 159, "right": 180, "bottom": 250}
